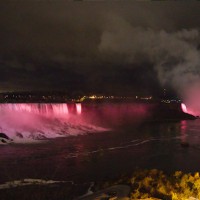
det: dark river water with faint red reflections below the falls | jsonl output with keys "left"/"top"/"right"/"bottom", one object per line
{"left": 0, "top": 120, "right": 200, "bottom": 186}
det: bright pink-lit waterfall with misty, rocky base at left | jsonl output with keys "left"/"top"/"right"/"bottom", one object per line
{"left": 0, "top": 103, "right": 105, "bottom": 143}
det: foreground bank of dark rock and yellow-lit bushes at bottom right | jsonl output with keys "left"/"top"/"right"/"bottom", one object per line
{"left": 77, "top": 169, "right": 200, "bottom": 200}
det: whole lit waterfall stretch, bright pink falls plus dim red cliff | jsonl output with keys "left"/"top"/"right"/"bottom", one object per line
{"left": 0, "top": 103, "right": 152, "bottom": 142}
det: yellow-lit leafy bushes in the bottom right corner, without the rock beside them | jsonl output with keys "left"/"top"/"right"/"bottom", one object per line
{"left": 130, "top": 169, "right": 200, "bottom": 200}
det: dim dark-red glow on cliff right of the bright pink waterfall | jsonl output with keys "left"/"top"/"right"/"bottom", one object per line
{"left": 82, "top": 103, "right": 152, "bottom": 128}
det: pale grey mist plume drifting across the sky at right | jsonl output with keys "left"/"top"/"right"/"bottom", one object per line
{"left": 99, "top": 16, "right": 200, "bottom": 104}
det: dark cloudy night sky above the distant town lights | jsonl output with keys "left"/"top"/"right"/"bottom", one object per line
{"left": 0, "top": 0, "right": 200, "bottom": 94}
